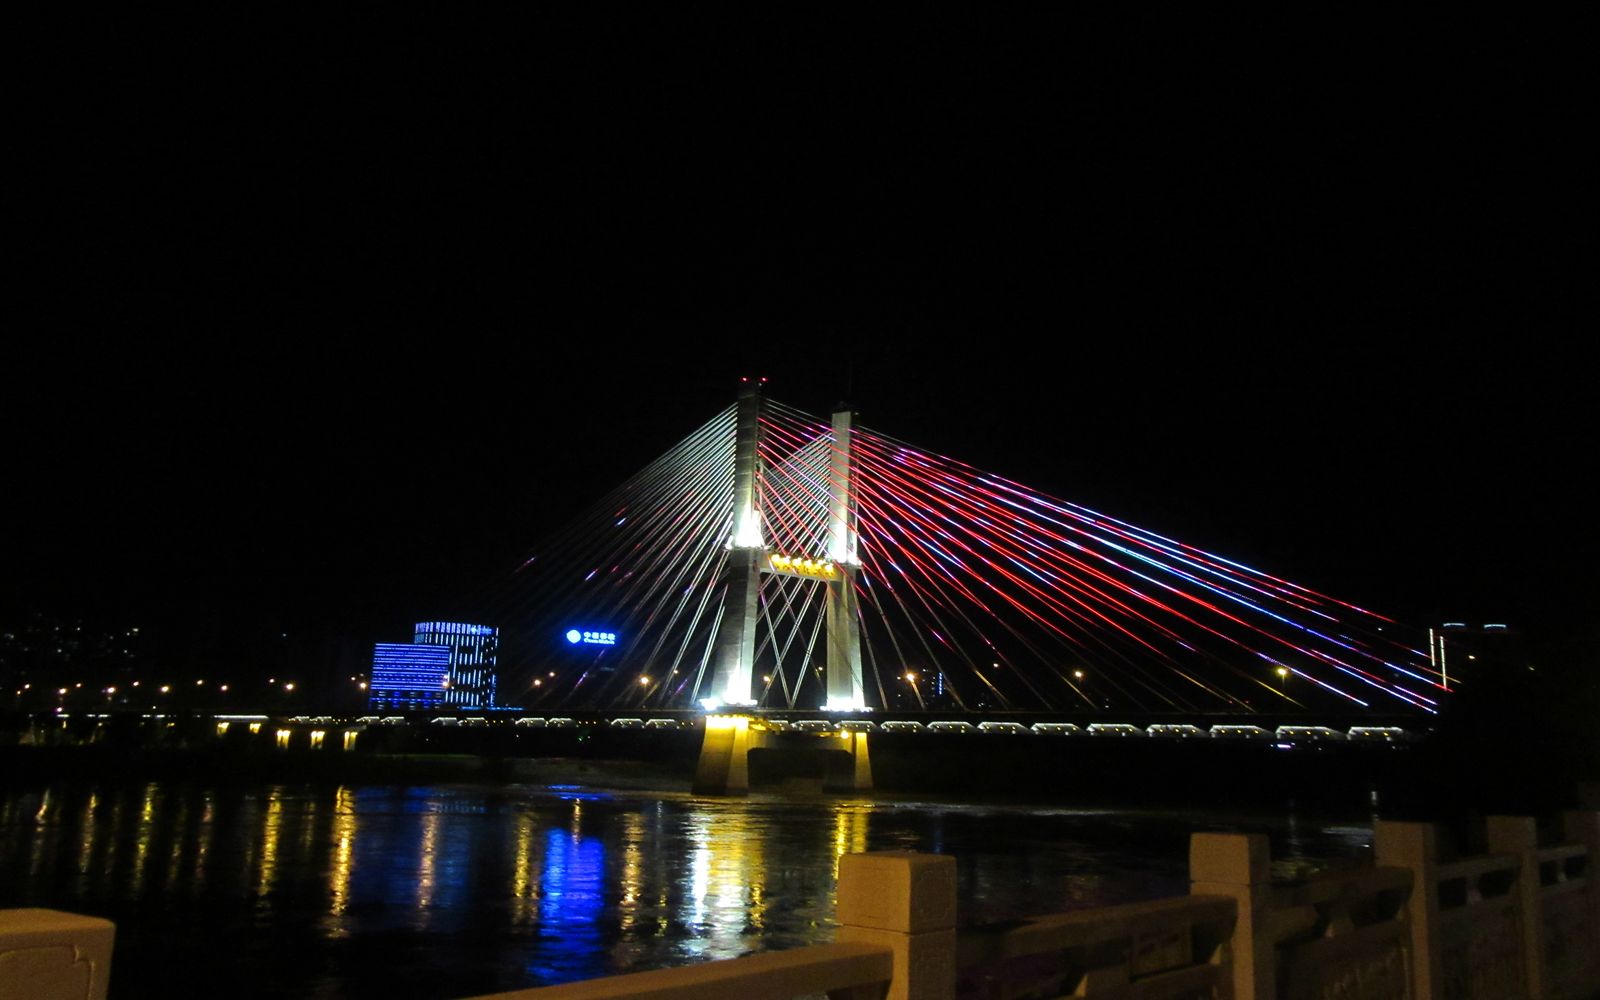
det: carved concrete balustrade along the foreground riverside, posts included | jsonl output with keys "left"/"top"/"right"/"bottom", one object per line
{"left": 0, "top": 813, "right": 1600, "bottom": 1000}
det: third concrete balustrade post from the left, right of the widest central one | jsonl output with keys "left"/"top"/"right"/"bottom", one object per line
{"left": 1189, "top": 834, "right": 1277, "bottom": 1000}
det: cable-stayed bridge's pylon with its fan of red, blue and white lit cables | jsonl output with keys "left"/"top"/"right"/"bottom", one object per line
{"left": 467, "top": 379, "right": 1450, "bottom": 790}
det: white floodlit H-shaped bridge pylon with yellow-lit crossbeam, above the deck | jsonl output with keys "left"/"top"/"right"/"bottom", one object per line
{"left": 709, "top": 379, "right": 867, "bottom": 712}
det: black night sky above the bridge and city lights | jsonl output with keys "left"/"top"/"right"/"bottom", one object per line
{"left": 0, "top": 5, "right": 1600, "bottom": 670}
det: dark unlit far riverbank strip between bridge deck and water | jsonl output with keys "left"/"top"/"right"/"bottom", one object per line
{"left": 9, "top": 716, "right": 1579, "bottom": 819}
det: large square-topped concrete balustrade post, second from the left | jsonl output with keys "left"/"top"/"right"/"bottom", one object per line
{"left": 838, "top": 851, "right": 955, "bottom": 1000}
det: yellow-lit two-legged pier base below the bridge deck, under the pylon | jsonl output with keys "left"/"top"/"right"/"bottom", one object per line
{"left": 691, "top": 715, "right": 872, "bottom": 795}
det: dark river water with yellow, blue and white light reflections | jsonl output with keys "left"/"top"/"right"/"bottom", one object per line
{"left": 0, "top": 782, "right": 1371, "bottom": 1000}
